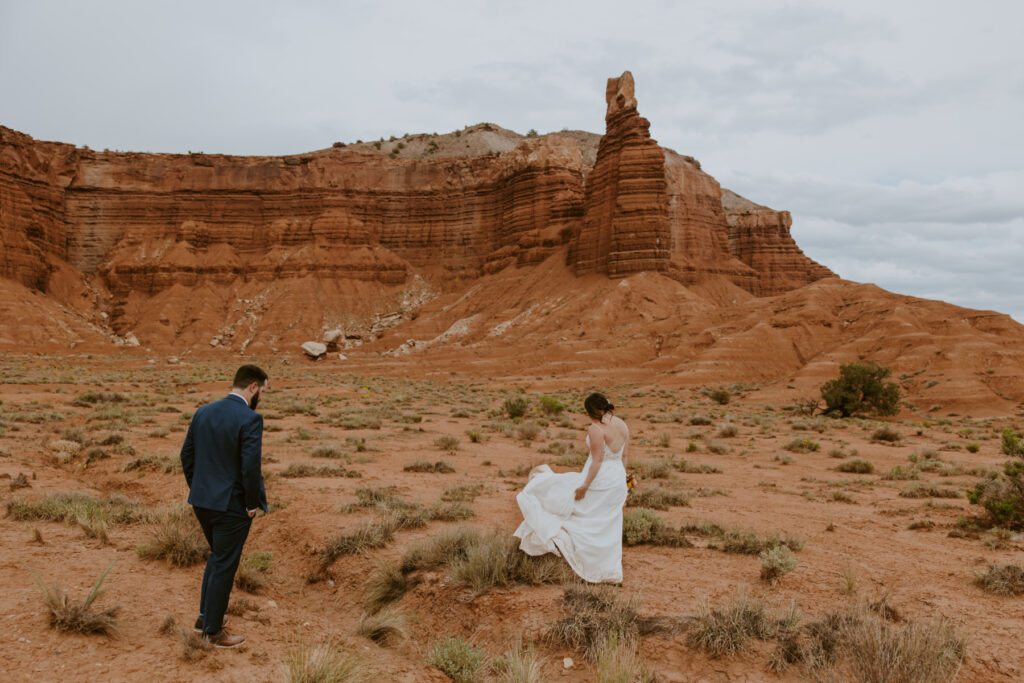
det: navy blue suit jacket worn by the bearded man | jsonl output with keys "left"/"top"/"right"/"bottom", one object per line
{"left": 181, "top": 394, "right": 267, "bottom": 512}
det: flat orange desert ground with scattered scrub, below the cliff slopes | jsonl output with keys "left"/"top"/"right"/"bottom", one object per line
{"left": 0, "top": 354, "right": 1024, "bottom": 681}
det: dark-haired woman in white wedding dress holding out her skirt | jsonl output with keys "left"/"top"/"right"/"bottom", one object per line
{"left": 515, "top": 393, "right": 630, "bottom": 584}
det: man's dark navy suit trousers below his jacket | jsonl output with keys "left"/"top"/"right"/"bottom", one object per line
{"left": 193, "top": 501, "right": 253, "bottom": 636}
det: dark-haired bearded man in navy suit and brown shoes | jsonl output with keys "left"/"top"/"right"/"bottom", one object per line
{"left": 181, "top": 366, "right": 267, "bottom": 647}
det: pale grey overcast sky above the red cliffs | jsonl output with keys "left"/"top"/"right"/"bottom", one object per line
{"left": 0, "top": 0, "right": 1024, "bottom": 322}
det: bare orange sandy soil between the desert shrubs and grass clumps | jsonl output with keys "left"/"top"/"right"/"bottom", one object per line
{"left": 0, "top": 355, "right": 1024, "bottom": 681}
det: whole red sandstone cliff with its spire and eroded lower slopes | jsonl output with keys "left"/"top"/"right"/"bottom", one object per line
{"left": 0, "top": 72, "right": 1024, "bottom": 417}
